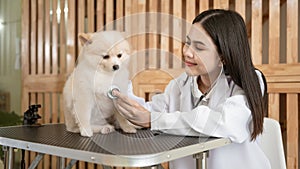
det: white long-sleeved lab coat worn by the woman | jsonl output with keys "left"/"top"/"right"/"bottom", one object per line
{"left": 127, "top": 71, "right": 271, "bottom": 169}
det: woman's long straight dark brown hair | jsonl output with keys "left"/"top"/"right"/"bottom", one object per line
{"left": 193, "top": 9, "right": 266, "bottom": 140}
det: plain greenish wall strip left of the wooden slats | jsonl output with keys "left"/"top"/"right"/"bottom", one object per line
{"left": 0, "top": 0, "right": 21, "bottom": 113}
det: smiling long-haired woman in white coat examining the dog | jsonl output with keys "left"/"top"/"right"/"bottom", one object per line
{"left": 113, "top": 9, "right": 270, "bottom": 169}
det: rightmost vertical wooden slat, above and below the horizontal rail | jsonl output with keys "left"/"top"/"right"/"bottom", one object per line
{"left": 286, "top": 0, "right": 300, "bottom": 168}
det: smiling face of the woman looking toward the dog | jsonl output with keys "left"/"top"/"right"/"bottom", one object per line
{"left": 183, "top": 23, "right": 222, "bottom": 77}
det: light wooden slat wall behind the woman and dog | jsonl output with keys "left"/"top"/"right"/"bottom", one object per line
{"left": 21, "top": 0, "right": 300, "bottom": 169}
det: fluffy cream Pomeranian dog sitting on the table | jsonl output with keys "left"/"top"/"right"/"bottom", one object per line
{"left": 63, "top": 31, "right": 136, "bottom": 137}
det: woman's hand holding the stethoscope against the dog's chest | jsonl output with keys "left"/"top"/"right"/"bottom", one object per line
{"left": 113, "top": 90, "right": 151, "bottom": 127}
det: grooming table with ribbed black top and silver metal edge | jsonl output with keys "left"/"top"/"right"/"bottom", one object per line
{"left": 0, "top": 124, "right": 230, "bottom": 169}
